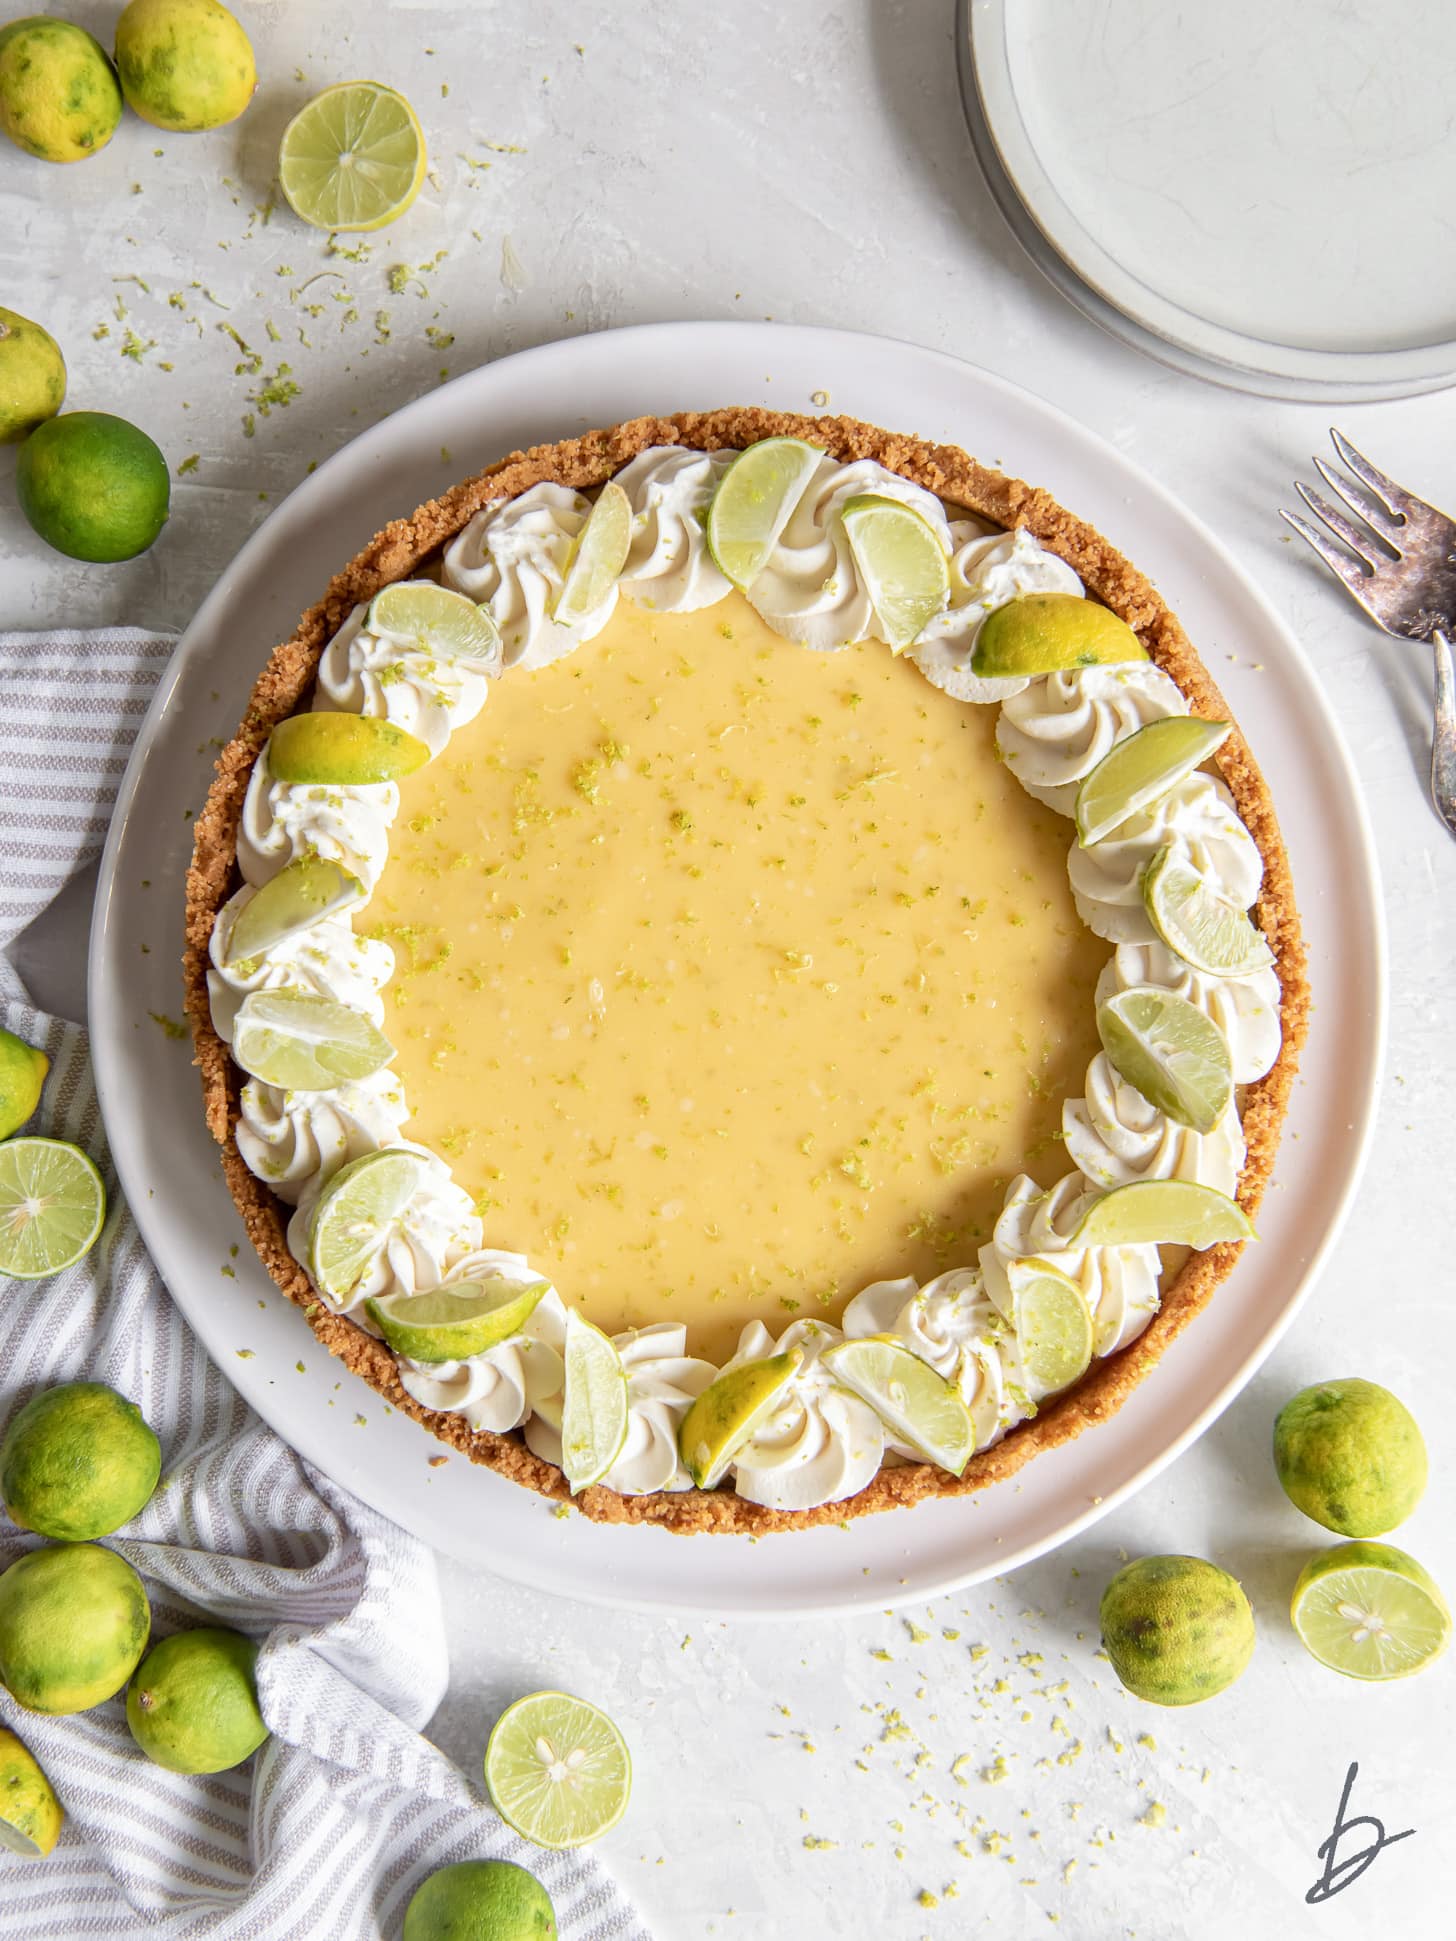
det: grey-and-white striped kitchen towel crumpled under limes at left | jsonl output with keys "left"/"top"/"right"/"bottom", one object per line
{"left": 0, "top": 629, "right": 646, "bottom": 1941}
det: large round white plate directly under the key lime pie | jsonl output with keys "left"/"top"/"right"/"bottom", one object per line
{"left": 89, "top": 324, "right": 1384, "bottom": 1613}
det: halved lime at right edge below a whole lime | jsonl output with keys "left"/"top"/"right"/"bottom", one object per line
{"left": 1289, "top": 1543, "right": 1450, "bottom": 1679}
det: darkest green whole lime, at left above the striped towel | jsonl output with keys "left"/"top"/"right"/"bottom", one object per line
{"left": 16, "top": 411, "right": 171, "bottom": 561}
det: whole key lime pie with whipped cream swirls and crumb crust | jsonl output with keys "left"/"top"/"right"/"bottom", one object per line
{"left": 186, "top": 410, "right": 1308, "bottom": 1531}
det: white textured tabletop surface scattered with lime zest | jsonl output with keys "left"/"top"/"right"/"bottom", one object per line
{"left": 0, "top": 0, "right": 1456, "bottom": 1941}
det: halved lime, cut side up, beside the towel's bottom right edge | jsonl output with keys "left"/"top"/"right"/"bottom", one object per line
{"left": 485, "top": 1693, "right": 633, "bottom": 1848}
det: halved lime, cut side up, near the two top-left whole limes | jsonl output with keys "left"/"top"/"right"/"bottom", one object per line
{"left": 278, "top": 82, "right": 425, "bottom": 229}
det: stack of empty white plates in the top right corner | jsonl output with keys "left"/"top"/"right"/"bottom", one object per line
{"left": 957, "top": 0, "right": 1456, "bottom": 402}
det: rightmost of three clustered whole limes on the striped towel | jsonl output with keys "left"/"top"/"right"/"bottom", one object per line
{"left": 126, "top": 1625, "right": 268, "bottom": 1772}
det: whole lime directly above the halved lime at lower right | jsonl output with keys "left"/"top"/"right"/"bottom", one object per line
{"left": 1274, "top": 1376, "right": 1427, "bottom": 1537}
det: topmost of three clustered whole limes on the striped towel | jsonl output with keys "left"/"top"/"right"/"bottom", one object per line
{"left": 0, "top": 1382, "right": 161, "bottom": 1543}
